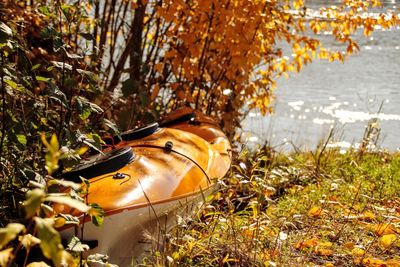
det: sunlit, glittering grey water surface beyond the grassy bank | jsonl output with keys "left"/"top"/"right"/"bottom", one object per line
{"left": 243, "top": 1, "right": 400, "bottom": 151}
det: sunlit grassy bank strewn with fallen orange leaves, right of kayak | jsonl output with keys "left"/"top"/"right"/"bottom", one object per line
{"left": 143, "top": 147, "right": 400, "bottom": 267}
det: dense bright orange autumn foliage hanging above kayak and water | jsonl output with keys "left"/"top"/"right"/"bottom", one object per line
{"left": 142, "top": 0, "right": 399, "bottom": 132}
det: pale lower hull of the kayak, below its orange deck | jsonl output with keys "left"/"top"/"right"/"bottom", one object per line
{"left": 61, "top": 185, "right": 216, "bottom": 266}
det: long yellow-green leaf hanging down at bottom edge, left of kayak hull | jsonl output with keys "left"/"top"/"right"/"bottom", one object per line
{"left": 35, "top": 220, "right": 63, "bottom": 266}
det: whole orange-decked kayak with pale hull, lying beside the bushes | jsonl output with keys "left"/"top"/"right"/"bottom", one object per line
{"left": 55, "top": 108, "right": 231, "bottom": 266}
